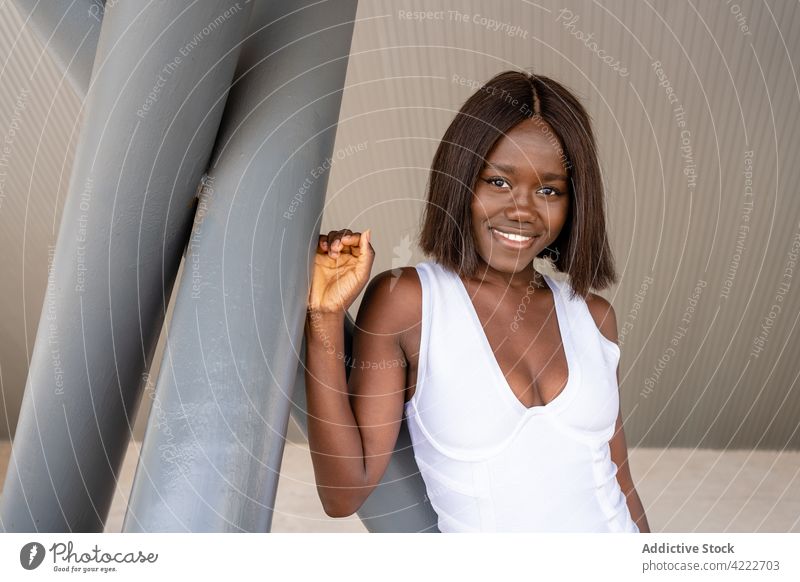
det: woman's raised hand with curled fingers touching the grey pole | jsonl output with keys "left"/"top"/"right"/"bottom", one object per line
{"left": 308, "top": 229, "right": 375, "bottom": 313}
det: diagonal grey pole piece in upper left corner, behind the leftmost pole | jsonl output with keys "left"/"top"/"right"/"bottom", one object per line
{"left": 14, "top": 0, "right": 104, "bottom": 98}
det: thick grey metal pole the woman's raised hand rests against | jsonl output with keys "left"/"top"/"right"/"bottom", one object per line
{"left": 123, "top": 0, "right": 356, "bottom": 532}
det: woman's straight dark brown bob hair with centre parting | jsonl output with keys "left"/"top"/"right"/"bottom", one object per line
{"left": 418, "top": 71, "right": 617, "bottom": 298}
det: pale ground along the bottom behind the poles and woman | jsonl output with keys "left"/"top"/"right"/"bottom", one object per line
{"left": 0, "top": 429, "right": 800, "bottom": 532}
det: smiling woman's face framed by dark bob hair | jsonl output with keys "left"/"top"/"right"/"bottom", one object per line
{"left": 471, "top": 118, "right": 569, "bottom": 273}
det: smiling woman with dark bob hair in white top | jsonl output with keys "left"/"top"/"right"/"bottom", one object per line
{"left": 306, "top": 71, "right": 649, "bottom": 533}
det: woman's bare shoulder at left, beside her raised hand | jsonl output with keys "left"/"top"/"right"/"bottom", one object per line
{"left": 357, "top": 267, "right": 422, "bottom": 334}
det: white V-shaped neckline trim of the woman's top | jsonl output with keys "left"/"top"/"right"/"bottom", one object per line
{"left": 451, "top": 264, "right": 577, "bottom": 414}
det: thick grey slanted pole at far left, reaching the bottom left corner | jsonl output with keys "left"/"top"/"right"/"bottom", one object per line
{"left": 0, "top": 0, "right": 251, "bottom": 531}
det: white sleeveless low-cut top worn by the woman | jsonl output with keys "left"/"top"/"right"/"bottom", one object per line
{"left": 405, "top": 261, "right": 639, "bottom": 533}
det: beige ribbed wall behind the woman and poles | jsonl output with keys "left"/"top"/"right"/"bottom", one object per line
{"left": 0, "top": 0, "right": 800, "bottom": 449}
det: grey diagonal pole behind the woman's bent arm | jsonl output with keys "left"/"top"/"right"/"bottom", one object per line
{"left": 292, "top": 320, "right": 439, "bottom": 533}
